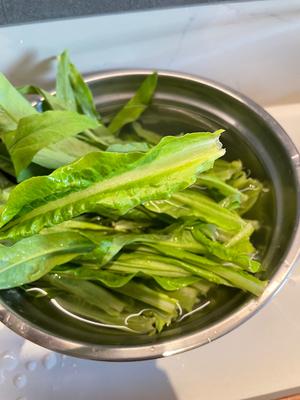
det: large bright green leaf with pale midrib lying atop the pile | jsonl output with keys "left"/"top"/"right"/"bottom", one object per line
{"left": 0, "top": 131, "right": 224, "bottom": 238}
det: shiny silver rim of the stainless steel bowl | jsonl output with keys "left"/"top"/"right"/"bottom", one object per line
{"left": 0, "top": 69, "right": 300, "bottom": 361}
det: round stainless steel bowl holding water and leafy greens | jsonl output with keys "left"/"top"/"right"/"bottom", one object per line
{"left": 0, "top": 70, "right": 300, "bottom": 361}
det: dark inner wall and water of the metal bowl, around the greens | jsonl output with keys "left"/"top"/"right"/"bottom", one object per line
{"left": 0, "top": 72, "right": 297, "bottom": 354}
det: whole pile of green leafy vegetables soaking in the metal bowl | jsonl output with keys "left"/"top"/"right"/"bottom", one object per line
{"left": 0, "top": 52, "right": 266, "bottom": 334}
